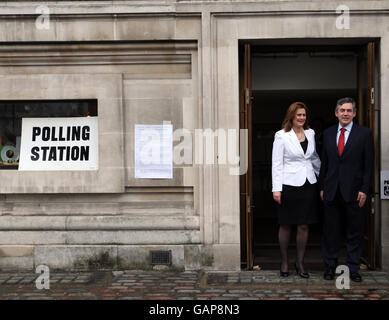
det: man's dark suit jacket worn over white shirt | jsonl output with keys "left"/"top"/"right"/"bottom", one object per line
{"left": 319, "top": 123, "right": 374, "bottom": 202}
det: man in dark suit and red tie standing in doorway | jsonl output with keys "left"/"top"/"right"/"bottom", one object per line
{"left": 319, "top": 98, "right": 374, "bottom": 282}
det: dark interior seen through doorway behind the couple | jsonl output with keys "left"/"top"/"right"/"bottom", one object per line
{"left": 252, "top": 47, "right": 358, "bottom": 269}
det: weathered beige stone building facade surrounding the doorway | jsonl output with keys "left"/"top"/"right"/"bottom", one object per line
{"left": 0, "top": 0, "right": 389, "bottom": 270}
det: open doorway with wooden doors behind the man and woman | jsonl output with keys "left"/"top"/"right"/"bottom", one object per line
{"left": 240, "top": 39, "right": 375, "bottom": 269}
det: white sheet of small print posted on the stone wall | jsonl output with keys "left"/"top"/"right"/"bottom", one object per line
{"left": 135, "top": 124, "right": 173, "bottom": 179}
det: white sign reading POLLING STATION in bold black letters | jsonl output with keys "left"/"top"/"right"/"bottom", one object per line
{"left": 19, "top": 117, "right": 99, "bottom": 171}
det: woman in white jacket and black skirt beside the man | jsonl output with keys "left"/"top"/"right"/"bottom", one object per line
{"left": 272, "top": 102, "right": 320, "bottom": 278}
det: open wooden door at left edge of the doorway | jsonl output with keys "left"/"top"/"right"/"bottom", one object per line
{"left": 239, "top": 44, "right": 254, "bottom": 269}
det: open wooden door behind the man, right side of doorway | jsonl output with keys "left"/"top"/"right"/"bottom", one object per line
{"left": 357, "top": 42, "right": 378, "bottom": 269}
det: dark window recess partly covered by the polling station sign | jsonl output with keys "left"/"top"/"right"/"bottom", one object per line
{"left": 0, "top": 99, "right": 97, "bottom": 169}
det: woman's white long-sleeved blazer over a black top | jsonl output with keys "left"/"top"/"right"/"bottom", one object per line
{"left": 272, "top": 129, "right": 321, "bottom": 192}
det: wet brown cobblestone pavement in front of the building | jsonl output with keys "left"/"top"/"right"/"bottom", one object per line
{"left": 0, "top": 270, "right": 389, "bottom": 300}
